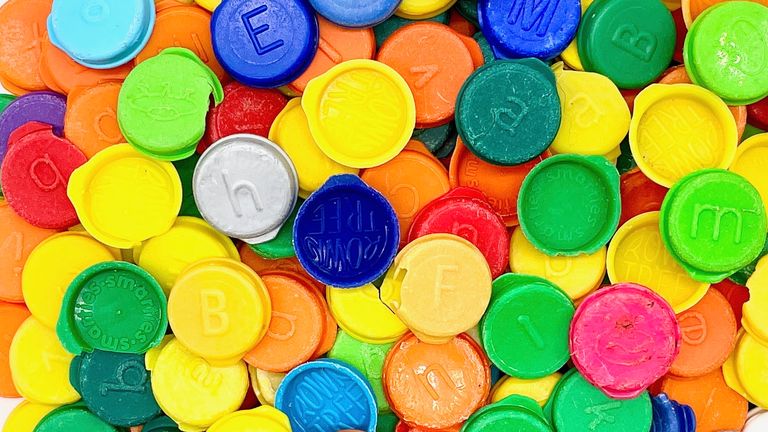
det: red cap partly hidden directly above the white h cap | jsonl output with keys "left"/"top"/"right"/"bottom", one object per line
{"left": 202, "top": 81, "right": 286, "bottom": 153}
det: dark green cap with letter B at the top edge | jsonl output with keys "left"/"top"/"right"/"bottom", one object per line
{"left": 577, "top": 0, "right": 677, "bottom": 89}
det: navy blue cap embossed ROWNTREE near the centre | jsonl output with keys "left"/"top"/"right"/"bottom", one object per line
{"left": 293, "top": 174, "right": 400, "bottom": 288}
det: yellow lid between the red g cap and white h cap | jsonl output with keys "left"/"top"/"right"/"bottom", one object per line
{"left": 67, "top": 144, "right": 182, "bottom": 249}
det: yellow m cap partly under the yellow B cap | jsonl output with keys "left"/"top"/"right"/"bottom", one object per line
{"left": 147, "top": 338, "right": 248, "bottom": 432}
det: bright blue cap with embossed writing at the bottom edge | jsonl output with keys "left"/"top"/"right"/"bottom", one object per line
{"left": 275, "top": 359, "right": 377, "bottom": 432}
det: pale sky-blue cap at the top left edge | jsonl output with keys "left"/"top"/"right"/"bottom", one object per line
{"left": 48, "top": 0, "right": 155, "bottom": 69}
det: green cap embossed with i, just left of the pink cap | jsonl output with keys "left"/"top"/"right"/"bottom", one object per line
{"left": 479, "top": 273, "right": 574, "bottom": 379}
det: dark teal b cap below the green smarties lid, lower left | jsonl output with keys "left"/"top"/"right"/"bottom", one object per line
{"left": 69, "top": 350, "right": 160, "bottom": 427}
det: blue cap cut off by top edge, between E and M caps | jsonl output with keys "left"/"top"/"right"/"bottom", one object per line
{"left": 309, "top": 0, "right": 402, "bottom": 28}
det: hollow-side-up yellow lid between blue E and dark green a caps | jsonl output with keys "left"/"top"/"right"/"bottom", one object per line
{"left": 301, "top": 60, "right": 416, "bottom": 168}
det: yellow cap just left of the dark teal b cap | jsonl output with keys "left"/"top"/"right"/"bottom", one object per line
{"left": 8, "top": 317, "right": 80, "bottom": 405}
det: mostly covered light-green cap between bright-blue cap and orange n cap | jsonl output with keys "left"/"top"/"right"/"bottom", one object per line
{"left": 328, "top": 331, "right": 394, "bottom": 413}
